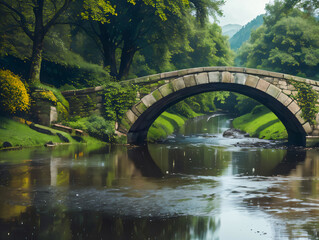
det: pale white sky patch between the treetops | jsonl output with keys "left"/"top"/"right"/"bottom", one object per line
{"left": 218, "top": 0, "right": 270, "bottom": 26}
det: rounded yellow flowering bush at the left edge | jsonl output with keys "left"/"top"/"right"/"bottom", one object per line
{"left": 0, "top": 70, "right": 31, "bottom": 115}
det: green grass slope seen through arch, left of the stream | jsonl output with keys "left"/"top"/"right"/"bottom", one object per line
{"left": 147, "top": 112, "right": 185, "bottom": 142}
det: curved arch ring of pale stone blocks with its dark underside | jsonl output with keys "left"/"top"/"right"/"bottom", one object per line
{"left": 120, "top": 68, "right": 311, "bottom": 145}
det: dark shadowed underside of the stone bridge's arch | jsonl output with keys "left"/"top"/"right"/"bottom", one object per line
{"left": 127, "top": 82, "right": 307, "bottom": 146}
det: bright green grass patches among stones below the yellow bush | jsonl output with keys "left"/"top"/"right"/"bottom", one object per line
{"left": 0, "top": 117, "right": 100, "bottom": 148}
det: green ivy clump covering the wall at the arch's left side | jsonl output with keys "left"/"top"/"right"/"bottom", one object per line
{"left": 104, "top": 82, "right": 137, "bottom": 122}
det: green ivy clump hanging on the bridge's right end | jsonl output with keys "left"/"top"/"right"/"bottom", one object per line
{"left": 289, "top": 80, "right": 319, "bottom": 124}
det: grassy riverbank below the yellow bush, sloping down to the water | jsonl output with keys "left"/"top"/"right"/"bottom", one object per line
{"left": 0, "top": 117, "right": 102, "bottom": 149}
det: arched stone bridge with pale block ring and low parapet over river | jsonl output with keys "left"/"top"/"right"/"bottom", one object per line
{"left": 63, "top": 67, "right": 319, "bottom": 146}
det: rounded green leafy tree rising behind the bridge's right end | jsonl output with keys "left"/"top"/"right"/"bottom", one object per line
{"left": 236, "top": 1, "right": 319, "bottom": 78}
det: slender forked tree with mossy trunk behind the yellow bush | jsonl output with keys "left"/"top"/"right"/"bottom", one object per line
{"left": 0, "top": 0, "right": 72, "bottom": 84}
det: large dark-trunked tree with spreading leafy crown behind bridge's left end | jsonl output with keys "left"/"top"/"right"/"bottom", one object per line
{"left": 78, "top": 0, "right": 223, "bottom": 80}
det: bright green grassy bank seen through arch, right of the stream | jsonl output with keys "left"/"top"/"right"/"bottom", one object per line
{"left": 233, "top": 106, "right": 288, "bottom": 140}
